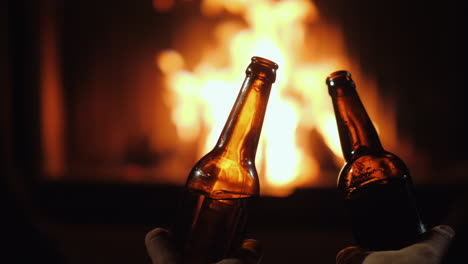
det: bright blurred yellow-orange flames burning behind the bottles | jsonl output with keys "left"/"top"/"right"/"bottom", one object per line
{"left": 155, "top": 0, "right": 392, "bottom": 195}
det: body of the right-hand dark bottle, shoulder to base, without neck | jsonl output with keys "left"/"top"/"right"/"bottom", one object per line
{"left": 338, "top": 152, "right": 425, "bottom": 250}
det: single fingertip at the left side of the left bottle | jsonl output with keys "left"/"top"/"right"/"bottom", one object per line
{"left": 145, "top": 228, "right": 176, "bottom": 264}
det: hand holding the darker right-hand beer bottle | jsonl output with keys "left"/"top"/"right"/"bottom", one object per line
{"left": 336, "top": 225, "right": 455, "bottom": 264}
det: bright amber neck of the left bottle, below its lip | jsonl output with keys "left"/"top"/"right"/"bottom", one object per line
{"left": 215, "top": 75, "right": 272, "bottom": 162}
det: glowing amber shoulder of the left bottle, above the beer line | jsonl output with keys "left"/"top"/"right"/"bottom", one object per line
{"left": 186, "top": 152, "right": 260, "bottom": 199}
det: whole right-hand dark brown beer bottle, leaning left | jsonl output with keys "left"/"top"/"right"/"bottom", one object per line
{"left": 326, "top": 71, "right": 425, "bottom": 250}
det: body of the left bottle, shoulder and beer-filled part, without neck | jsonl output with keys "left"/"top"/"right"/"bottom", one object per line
{"left": 174, "top": 150, "right": 260, "bottom": 264}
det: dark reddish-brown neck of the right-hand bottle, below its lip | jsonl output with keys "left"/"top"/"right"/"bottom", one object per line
{"left": 329, "top": 76, "right": 383, "bottom": 161}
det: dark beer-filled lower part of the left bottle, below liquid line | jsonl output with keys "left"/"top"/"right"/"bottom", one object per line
{"left": 174, "top": 190, "right": 256, "bottom": 263}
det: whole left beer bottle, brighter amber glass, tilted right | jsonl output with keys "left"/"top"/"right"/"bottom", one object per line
{"left": 174, "top": 57, "right": 278, "bottom": 264}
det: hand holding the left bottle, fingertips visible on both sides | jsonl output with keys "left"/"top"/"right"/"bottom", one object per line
{"left": 145, "top": 228, "right": 262, "bottom": 264}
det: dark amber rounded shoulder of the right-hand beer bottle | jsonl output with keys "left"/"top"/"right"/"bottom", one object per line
{"left": 338, "top": 151, "right": 411, "bottom": 194}
